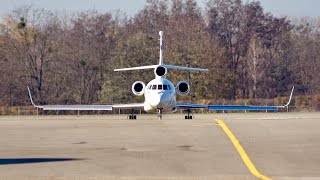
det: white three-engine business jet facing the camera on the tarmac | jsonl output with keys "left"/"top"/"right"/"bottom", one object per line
{"left": 28, "top": 31, "right": 294, "bottom": 120}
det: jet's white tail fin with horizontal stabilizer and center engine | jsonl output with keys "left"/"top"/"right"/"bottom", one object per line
{"left": 114, "top": 31, "right": 209, "bottom": 77}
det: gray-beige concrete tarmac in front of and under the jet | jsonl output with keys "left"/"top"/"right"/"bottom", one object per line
{"left": 0, "top": 113, "right": 320, "bottom": 179}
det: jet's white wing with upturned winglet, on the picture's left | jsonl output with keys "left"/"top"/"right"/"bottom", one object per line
{"left": 28, "top": 87, "right": 144, "bottom": 111}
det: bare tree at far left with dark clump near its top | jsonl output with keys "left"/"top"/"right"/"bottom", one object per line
{"left": 0, "top": 7, "right": 60, "bottom": 103}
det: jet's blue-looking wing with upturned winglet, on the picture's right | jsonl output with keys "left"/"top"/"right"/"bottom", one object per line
{"left": 177, "top": 87, "right": 294, "bottom": 111}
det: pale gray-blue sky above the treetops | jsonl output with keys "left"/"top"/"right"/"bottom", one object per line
{"left": 0, "top": 0, "right": 320, "bottom": 17}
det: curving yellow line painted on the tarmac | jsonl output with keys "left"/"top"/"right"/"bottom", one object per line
{"left": 216, "top": 119, "right": 271, "bottom": 180}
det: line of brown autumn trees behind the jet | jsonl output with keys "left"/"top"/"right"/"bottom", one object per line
{"left": 0, "top": 0, "right": 320, "bottom": 106}
